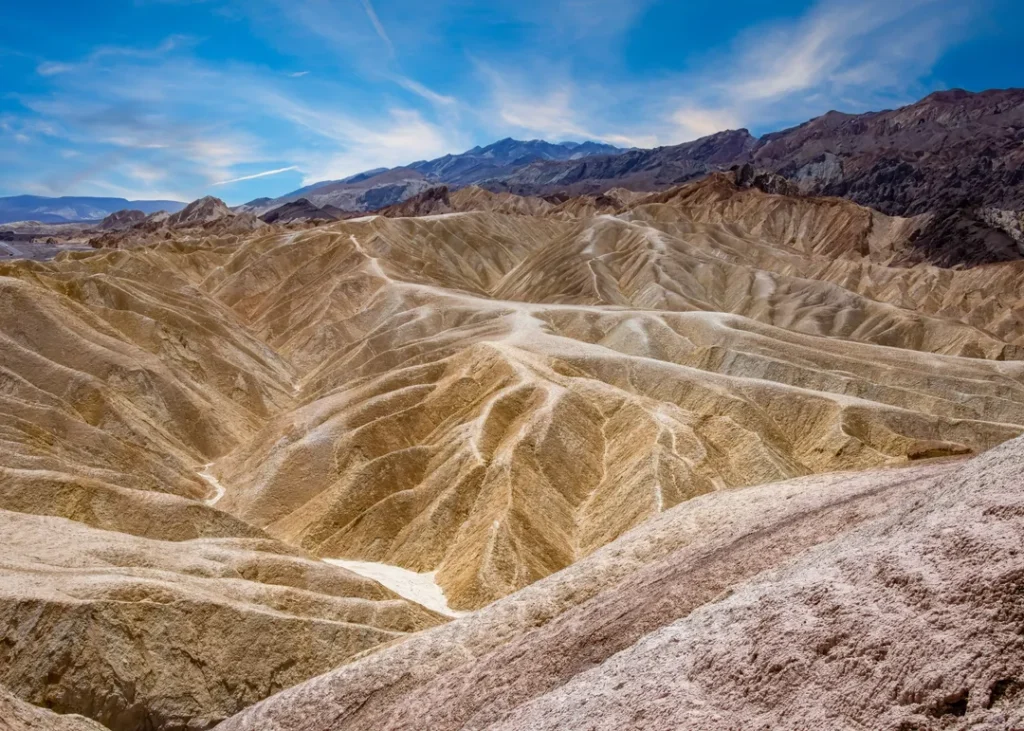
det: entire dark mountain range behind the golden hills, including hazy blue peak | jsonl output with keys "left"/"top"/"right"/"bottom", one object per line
{"left": 235, "top": 89, "right": 1024, "bottom": 264}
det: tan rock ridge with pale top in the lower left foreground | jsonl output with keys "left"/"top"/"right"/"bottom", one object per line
{"left": 0, "top": 511, "right": 442, "bottom": 731}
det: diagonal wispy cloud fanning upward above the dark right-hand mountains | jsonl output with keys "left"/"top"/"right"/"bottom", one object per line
{"left": 673, "top": 0, "right": 977, "bottom": 133}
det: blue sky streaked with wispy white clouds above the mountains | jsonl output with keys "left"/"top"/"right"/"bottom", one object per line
{"left": 0, "top": 0, "right": 1024, "bottom": 204}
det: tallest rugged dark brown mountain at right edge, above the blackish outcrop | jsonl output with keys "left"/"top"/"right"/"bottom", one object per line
{"left": 752, "top": 89, "right": 1024, "bottom": 215}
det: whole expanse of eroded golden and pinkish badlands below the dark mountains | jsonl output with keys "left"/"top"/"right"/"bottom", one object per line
{"left": 0, "top": 168, "right": 1024, "bottom": 731}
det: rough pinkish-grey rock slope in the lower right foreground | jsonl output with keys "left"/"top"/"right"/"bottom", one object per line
{"left": 221, "top": 439, "right": 1024, "bottom": 731}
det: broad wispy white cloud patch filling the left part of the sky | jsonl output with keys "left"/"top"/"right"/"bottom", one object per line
{"left": 9, "top": 30, "right": 470, "bottom": 197}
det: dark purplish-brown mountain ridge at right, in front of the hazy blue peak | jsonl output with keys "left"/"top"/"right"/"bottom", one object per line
{"left": 482, "top": 89, "right": 1024, "bottom": 266}
